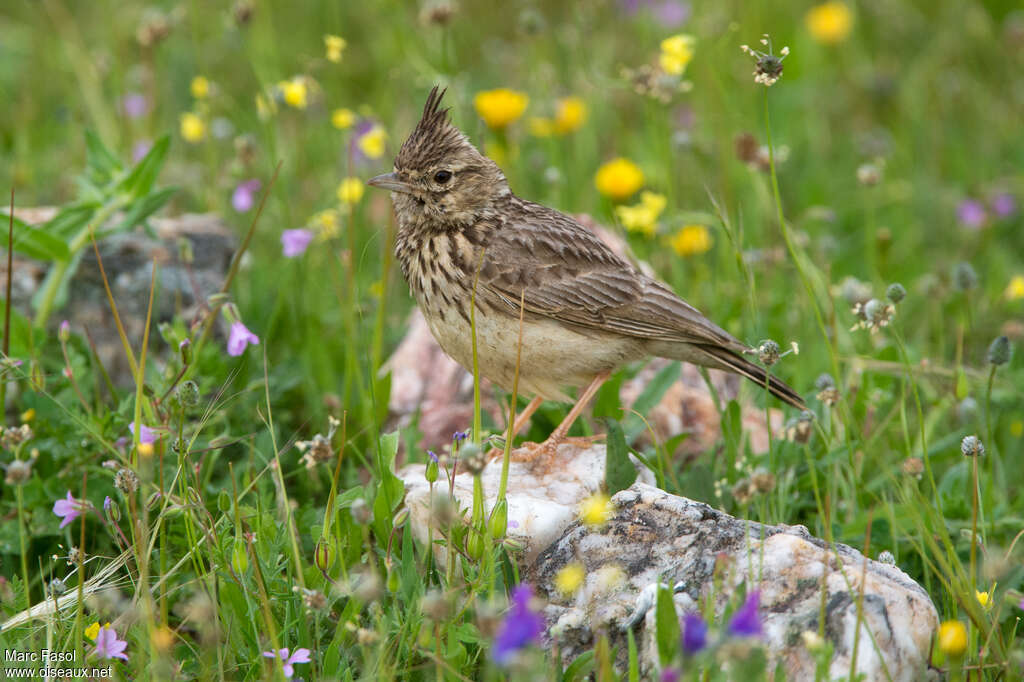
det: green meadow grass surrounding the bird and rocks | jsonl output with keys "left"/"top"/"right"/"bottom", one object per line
{"left": 0, "top": 0, "right": 1024, "bottom": 679}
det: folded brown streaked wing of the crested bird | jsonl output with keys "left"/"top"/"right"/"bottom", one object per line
{"left": 479, "top": 202, "right": 746, "bottom": 352}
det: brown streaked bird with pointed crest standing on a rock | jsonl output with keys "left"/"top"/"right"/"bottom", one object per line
{"left": 368, "top": 86, "right": 806, "bottom": 459}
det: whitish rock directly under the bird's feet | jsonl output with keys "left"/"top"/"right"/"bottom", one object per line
{"left": 398, "top": 438, "right": 654, "bottom": 565}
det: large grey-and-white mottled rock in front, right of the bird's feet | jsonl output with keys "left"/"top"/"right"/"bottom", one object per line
{"left": 524, "top": 482, "right": 938, "bottom": 681}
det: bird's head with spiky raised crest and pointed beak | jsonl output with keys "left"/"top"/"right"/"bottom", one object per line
{"left": 369, "top": 86, "right": 509, "bottom": 229}
